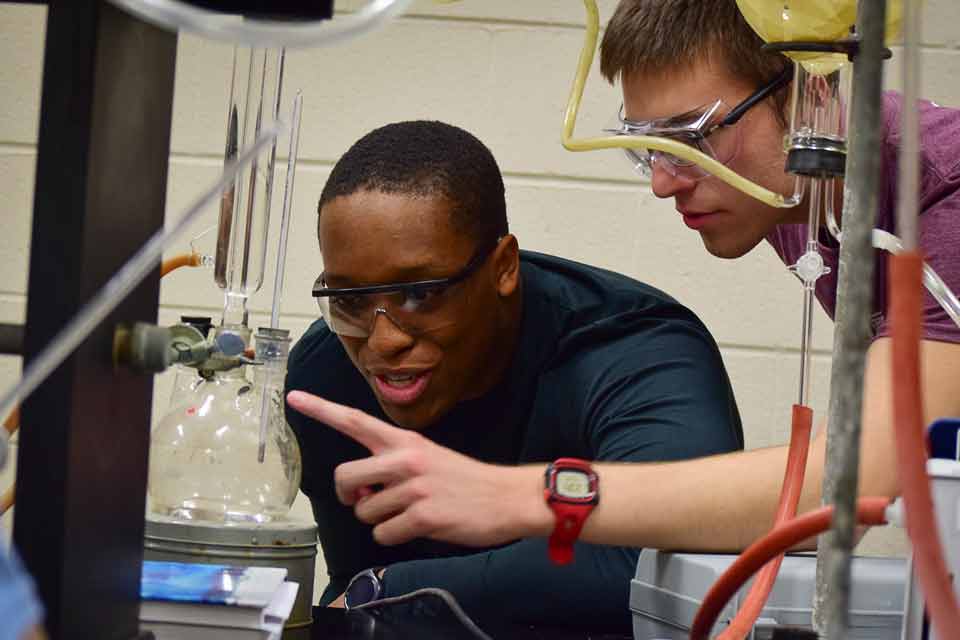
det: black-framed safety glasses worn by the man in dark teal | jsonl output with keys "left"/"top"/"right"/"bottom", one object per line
{"left": 313, "top": 239, "right": 499, "bottom": 338}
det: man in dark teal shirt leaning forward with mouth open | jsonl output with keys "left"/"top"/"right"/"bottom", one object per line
{"left": 287, "top": 122, "right": 743, "bottom": 630}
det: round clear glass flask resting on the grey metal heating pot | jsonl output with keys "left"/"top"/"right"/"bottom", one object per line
{"left": 149, "top": 330, "right": 301, "bottom": 524}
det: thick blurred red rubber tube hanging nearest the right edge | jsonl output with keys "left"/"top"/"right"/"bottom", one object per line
{"left": 888, "top": 252, "right": 960, "bottom": 638}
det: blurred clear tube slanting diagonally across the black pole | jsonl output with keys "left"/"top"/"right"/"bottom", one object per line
{"left": 0, "top": 122, "right": 284, "bottom": 428}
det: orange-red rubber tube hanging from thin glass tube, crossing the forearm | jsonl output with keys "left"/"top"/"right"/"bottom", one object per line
{"left": 716, "top": 404, "right": 813, "bottom": 640}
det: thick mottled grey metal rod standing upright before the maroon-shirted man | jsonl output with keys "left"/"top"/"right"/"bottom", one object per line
{"left": 817, "top": 0, "right": 887, "bottom": 640}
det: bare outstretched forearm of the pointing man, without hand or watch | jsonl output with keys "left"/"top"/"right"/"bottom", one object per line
{"left": 511, "top": 420, "right": 897, "bottom": 551}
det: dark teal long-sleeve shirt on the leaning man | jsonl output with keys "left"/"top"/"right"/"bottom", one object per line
{"left": 287, "top": 251, "right": 743, "bottom": 630}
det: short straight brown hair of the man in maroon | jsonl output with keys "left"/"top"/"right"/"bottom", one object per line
{"left": 600, "top": 0, "right": 792, "bottom": 124}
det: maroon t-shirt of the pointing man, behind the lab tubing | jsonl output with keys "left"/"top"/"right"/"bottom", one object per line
{"left": 767, "top": 92, "right": 960, "bottom": 342}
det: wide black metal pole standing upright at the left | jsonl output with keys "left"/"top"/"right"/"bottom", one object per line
{"left": 14, "top": 0, "right": 176, "bottom": 640}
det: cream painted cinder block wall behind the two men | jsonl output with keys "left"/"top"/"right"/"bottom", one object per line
{"left": 0, "top": 0, "right": 960, "bottom": 600}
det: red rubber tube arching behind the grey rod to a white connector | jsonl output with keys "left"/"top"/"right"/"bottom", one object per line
{"left": 690, "top": 498, "right": 890, "bottom": 640}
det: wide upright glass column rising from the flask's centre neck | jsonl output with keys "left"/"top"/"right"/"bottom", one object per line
{"left": 214, "top": 47, "right": 284, "bottom": 326}
